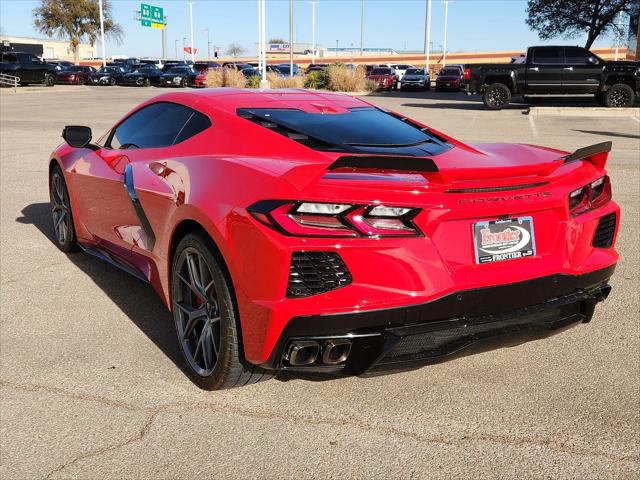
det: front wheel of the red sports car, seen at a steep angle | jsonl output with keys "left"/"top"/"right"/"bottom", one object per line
{"left": 49, "top": 166, "right": 77, "bottom": 252}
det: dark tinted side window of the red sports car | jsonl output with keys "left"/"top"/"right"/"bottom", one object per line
{"left": 109, "top": 102, "right": 211, "bottom": 149}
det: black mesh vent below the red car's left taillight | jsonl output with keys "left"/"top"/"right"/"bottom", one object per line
{"left": 287, "top": 252, "right": 352, "bottom": 298}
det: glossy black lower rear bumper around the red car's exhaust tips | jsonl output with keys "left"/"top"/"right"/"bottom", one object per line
{"left": 262, "top": 265, "right": 615, "bottom": 375}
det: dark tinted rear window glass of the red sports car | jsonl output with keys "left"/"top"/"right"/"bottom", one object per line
{"left": 238, "top": 107, "right": 447, "bottom": 156}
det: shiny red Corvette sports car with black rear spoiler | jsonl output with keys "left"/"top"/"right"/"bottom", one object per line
{"left": 49, "top": 89, "right": 620, "bottom": 389}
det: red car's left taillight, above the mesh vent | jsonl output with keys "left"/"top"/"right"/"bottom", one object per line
{"left": 247, "top": 200, "right": 421, "bottom": 237}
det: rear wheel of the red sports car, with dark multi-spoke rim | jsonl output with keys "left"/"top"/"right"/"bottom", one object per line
{"left": 171, "top": 232, "right": 271, "bottom": 390}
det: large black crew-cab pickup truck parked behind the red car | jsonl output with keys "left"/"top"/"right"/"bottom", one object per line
{"left": 463, "top": 46, "right": 640, "bottom": 110}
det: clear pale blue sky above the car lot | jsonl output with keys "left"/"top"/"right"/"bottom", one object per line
{"left": 0, "top": 0, "right": 614, "bottom": 57}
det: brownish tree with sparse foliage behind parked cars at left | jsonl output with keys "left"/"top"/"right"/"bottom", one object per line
{"left": 33, "top": 0, "right": 123, "bottom": 63}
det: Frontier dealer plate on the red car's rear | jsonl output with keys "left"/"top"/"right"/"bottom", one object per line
{"left": 473, "top": 217, "right": 536, "bottom": 263}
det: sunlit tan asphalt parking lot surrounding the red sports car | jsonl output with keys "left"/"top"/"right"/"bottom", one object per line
{"left": 0, "top": 87, "right": 640, "bottom": 479}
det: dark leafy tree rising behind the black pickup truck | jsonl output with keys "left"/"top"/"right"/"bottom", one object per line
{"left": 526, "top": 0, "right": 633, "bottom": 48}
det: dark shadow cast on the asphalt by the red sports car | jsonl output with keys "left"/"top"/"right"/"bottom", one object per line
{"left": 16, "top": 203, "right": 337, "bottom": 381}
